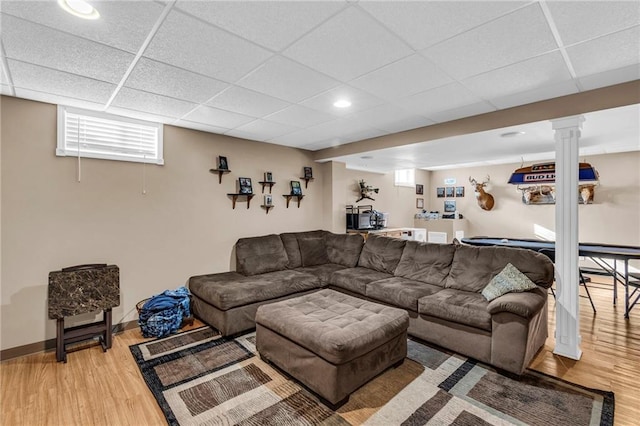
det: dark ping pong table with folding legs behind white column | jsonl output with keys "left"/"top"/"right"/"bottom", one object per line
{"left": 462, "top": 237, "right": 640, "bottom": 318}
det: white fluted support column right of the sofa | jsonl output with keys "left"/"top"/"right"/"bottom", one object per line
{"left": 551, "top": 115, "right": 584, "bottom": 359}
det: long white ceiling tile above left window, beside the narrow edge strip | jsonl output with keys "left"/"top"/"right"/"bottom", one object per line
{"left": 8, "top": 59, "right": 116, "bottom": 104}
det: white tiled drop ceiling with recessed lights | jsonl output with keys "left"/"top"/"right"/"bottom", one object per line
{"left": 0, "top": 0, "right": 640, "bottom": 171}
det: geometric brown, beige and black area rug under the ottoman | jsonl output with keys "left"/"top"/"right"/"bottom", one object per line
{"left": 130, "top": 327, "right": 614, "bottom": 426}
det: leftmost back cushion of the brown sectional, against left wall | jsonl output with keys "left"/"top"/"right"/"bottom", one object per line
{"left": 236, "top": 234, "right": 289, "bottom": 275}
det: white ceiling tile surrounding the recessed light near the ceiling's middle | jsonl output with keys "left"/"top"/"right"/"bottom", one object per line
{"left": 300, "top": 84, "right": 384, "bottom": 117}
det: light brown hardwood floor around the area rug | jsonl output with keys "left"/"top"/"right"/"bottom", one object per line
{"left": 0, "top": 283, "right": 640, "bottom": 426}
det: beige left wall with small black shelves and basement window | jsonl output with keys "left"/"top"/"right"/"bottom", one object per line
{"left": 0, "top": 97, "right": 323, "bottom": 349}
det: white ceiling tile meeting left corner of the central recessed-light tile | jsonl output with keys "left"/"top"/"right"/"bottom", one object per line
{"left": 207, "top": 86, "right": 291, "bottom": 117}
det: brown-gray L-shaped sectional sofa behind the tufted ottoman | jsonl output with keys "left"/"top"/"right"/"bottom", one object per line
{"left": 189, "top": 231, "right": 553, "bottom": 374}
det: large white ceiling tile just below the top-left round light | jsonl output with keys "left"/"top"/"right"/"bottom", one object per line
{"left": 1, "top": 14, "right": 134, "bottom": 83}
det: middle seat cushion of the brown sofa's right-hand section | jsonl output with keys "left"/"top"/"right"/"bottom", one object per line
{"left": 365, "top": 277, "right": 442, "bottom": 312}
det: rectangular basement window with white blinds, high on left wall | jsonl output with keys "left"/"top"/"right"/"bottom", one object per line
{"left": 56, "top": 106, "right": 164, "bottom": 165}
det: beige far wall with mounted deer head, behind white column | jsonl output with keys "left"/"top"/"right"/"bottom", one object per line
{"left": 427, "top": 152, "right": 640, "bottom": 246}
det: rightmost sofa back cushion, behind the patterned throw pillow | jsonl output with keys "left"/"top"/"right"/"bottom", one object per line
{"left": 445, "top": 245, "right": 553, "bottom": 292}
